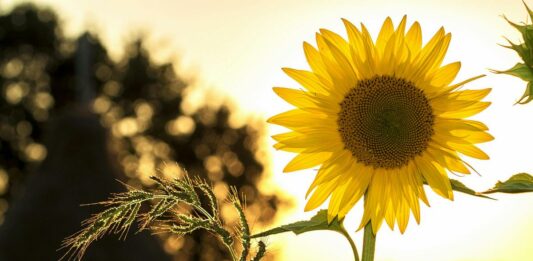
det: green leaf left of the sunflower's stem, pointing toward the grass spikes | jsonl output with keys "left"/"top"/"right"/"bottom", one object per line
{"left": 251, "top": 209, "right": 343, "bottom": 238}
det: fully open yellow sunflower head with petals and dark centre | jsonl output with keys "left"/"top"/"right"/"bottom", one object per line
{"left": 268, "top": 16, "right": 493, "bottom": 233}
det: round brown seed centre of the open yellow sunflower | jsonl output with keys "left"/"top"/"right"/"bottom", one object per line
{"left": 337, "top": 76, "right": 434, "bottom": 169}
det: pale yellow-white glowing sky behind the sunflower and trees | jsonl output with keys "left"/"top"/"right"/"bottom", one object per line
{"left": 0, "top": 0, "right": 533, "bottom": 261}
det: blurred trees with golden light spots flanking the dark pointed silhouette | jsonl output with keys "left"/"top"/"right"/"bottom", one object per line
{"left": 0, "top": 4, "right": 280, "bottom": 260}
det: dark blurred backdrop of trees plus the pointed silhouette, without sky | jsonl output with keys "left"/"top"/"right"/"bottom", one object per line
{"left": 0, "top": 4, "right": 280, "bottom": 260}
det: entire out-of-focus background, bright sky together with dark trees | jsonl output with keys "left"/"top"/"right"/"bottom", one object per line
{"left": 0, "top": 0, "right": 533, "bottom": 261}
